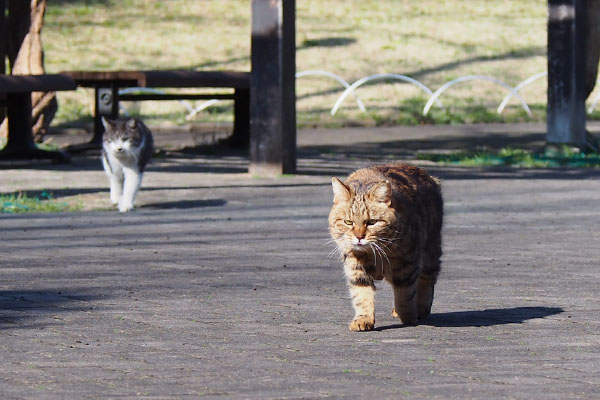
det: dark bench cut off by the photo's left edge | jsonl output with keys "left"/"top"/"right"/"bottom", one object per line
{"left": 0, "top": 74, "right": 77, "bottom": 162}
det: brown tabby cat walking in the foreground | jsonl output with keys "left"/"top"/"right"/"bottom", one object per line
{"left": 329, "top": 164, "right": 443, "bottom": 331}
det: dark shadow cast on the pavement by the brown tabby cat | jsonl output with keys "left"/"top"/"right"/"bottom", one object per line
{"left": 375, "top": 307, "right": 564, "bottom": 331}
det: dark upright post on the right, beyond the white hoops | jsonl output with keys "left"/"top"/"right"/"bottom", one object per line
{"left": 546, "top": 0, "right": 586, "bottom": 148}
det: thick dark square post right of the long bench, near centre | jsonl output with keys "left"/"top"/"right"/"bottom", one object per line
{"left": 249, "top": 0, "right": 296, "bottom": 176}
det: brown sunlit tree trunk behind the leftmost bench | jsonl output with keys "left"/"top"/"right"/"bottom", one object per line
{"left": 0, "top": 0, "right": 58, "bottom": 142}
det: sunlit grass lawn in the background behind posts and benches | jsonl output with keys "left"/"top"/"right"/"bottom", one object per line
{"left": 43, "top": 0, "right": 594, "bottom": 126}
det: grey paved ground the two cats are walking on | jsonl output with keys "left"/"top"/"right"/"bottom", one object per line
{"left": 0, "top": 125, "right": 600, "bottom": 399}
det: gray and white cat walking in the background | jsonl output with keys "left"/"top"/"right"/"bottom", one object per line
{"left": 102, "top": 117, "right": 154, "bottom": 212}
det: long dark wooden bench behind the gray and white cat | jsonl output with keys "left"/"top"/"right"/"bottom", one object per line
{"left": 63, "top": 70, "right": 250, "bottom": 147}
